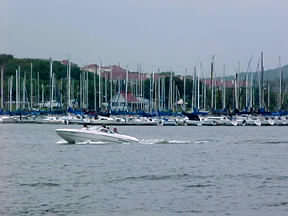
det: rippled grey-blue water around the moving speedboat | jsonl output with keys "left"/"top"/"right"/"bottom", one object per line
{"left": 0, "top": 124, "right": 288, "bottom": 216}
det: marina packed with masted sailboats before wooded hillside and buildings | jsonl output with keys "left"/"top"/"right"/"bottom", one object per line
{"left": 0, "top": 52, "right": 288, "bottom": 126}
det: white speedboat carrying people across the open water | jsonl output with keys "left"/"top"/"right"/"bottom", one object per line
{"left": 56, "top": 126, "right": 139, "bottom": 143}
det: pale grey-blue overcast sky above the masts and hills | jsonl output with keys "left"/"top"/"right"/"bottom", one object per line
{"left": 0, "top": 0, "right": 288, "bottom": 73}
